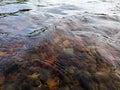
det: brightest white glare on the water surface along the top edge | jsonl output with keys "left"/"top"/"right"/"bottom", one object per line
{"left": 27, "top": 0, "right": 119, "bottom": 14}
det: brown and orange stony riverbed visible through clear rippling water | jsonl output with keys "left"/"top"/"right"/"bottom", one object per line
{"left": 0, "top": 18, "right": 120, "bottom": 90}
